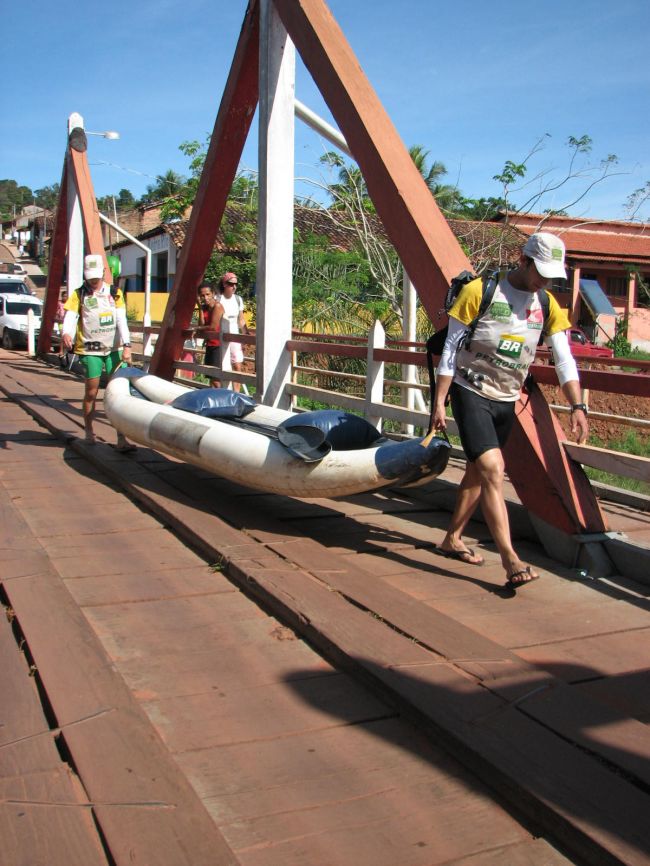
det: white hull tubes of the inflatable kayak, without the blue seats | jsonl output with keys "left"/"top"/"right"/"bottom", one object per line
{"left": 104, "top": 375, "right": 449, "bottom": 498}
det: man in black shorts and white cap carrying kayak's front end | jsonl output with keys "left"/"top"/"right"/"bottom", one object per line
{"left": 433, "top": 232, "right": 588, "bottom": 589}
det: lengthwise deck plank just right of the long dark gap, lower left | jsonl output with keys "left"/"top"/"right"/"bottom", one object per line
{"left": 5, "top": 496, "right": 235, "bottom": 866}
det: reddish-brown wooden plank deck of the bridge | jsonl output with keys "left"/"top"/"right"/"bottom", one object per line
{"left": 0, "top": 352, "right": 650, "bottom": 866}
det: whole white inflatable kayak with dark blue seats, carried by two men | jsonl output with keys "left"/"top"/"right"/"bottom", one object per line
{"left": 104, "top": 368, "right": 450, "bottom": 498}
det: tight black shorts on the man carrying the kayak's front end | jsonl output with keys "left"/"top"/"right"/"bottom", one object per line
{"left": 449, "top": 382, "right": 516, "bottom": 463}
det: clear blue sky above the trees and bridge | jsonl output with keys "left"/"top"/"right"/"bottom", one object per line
{"left": 0, "top": 0, "right": 650, "bottom": 220}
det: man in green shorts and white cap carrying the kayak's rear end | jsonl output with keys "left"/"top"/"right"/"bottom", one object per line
{"left": 62, "top": 254, "right": 135, "bottom": 452}
